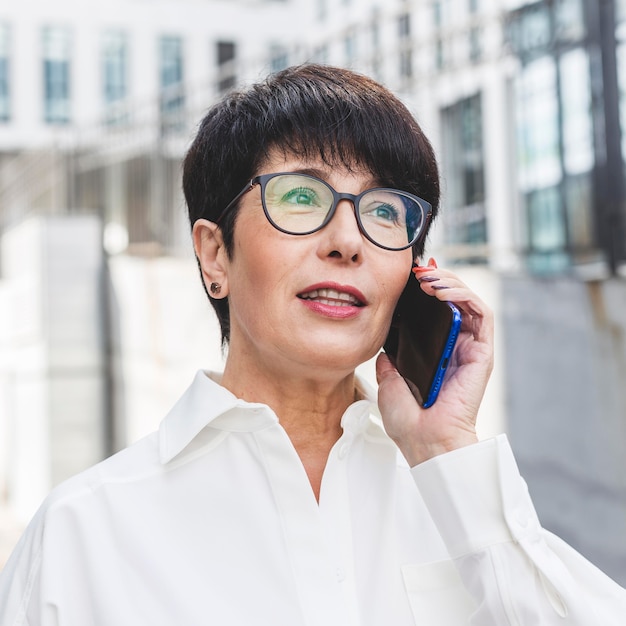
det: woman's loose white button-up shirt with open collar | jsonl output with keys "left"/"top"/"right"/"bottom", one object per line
{"left": 0, "top": 372, "right": 626, "bottom": 626}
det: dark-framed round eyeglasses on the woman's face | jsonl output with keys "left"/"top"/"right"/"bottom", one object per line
{"left": 216, "top": 173, "right": 432, "bottom": 250}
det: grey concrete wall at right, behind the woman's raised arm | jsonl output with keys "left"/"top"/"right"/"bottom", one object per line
{"left": 502, "top": 277, "right": 626, "bottom": 584}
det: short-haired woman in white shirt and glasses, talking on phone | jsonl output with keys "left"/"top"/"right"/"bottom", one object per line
{"left": 0, "top": 65, "right": 626, "bottom": 626}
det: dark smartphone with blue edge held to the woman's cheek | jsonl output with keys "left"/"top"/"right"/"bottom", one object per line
{"left": 383, "top": 273, "right": 461, "bottom": 408}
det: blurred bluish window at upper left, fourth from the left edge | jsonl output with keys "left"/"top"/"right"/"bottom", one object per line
{"left": 160, "top": 35, "right": 185, "bottom": 126}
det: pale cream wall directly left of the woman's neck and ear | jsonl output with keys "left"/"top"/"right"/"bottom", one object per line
{"left": 109, "top": 251, "right": 223, "bottom": 449}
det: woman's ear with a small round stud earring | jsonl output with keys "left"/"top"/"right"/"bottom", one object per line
{"left": 192, "top": 219, "right": 228, "bottom": 299}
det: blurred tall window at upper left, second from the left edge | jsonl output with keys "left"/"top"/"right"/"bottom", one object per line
{"left": 42, "top": 26, "right": 71, "bottom": 124}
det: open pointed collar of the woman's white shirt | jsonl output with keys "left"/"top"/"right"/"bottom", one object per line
{"left": 159, "top": 370, "right": 389, "bottom": 464}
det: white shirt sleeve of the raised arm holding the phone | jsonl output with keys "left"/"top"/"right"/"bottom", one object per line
{"left": 411, "top": 435, "right": 626, "bottom": 626}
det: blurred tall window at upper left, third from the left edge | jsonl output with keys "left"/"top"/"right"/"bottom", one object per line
{"left": 102, "top": 30, "right": 128, "bottom": 123}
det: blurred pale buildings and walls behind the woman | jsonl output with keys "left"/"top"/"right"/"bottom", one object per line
{"left": 0, "top": 0, "right": 626, "bottom": 584}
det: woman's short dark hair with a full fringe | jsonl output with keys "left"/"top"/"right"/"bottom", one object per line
{"left": 183, "top": 64, "right": 439, "bottom": 343}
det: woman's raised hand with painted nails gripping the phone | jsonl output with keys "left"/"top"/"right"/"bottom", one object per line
{"left": 376, "top": 259, "right": 493, "bottom": 467}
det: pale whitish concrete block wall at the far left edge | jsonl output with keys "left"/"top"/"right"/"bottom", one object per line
{"left": 0, "top": 216, "right": 103, "bottom": 520}
